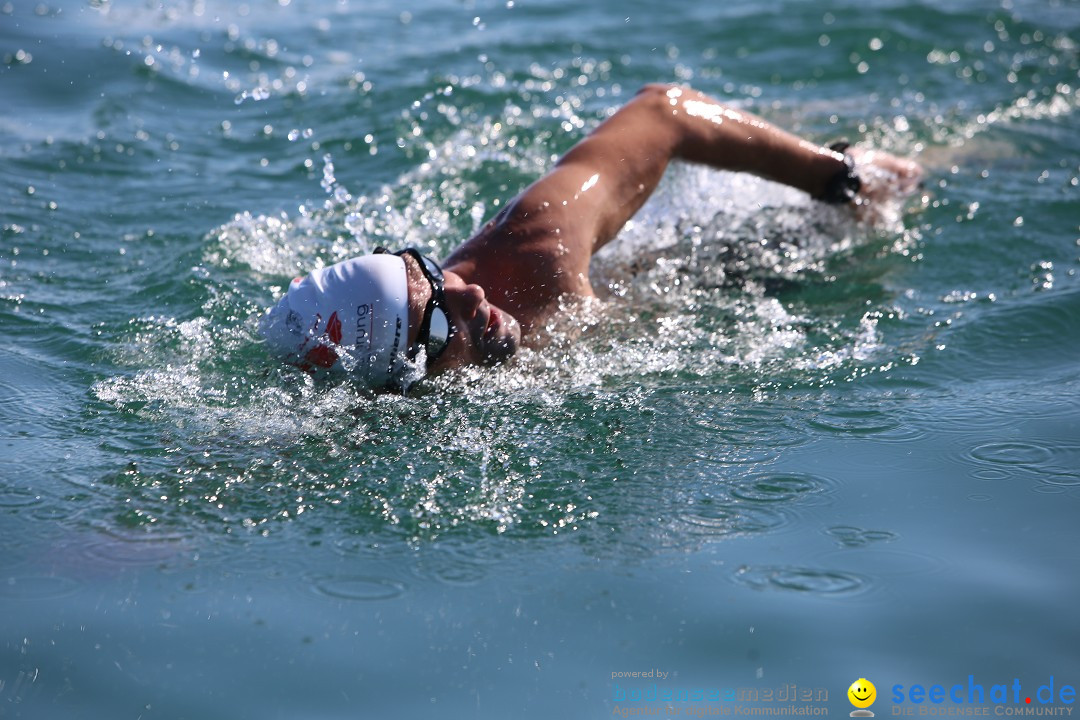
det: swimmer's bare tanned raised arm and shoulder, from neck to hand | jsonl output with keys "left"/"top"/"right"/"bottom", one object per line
{"left": 444, "top": 85, "right": 920, "bottom": 349}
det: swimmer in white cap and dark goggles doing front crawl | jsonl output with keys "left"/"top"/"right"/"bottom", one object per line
{"left": 259, "top": 84, "right": 922, "bottom": 391}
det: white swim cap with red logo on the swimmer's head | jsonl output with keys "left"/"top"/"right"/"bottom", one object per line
{"left": 259, "top": 255, "right": 408, "bottom": 388}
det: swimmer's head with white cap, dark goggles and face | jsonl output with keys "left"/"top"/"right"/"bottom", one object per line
{"left": 259, "top": 248, "right": 521, "bottom": 390}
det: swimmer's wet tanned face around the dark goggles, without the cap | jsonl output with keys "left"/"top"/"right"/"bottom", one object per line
{"left": 403, "top": 255, "right": 522, "bottom": 375}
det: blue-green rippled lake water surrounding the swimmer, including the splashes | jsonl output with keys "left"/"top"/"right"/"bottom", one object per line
{"left": 0, "top": 0, "right": 1080, "bottom": 720}
